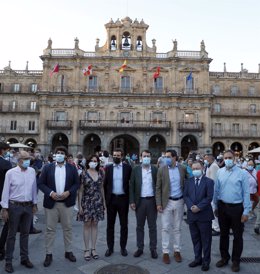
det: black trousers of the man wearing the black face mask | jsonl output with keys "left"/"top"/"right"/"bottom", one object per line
{"left": 107, "top": 195, "right": 129, "bottom": 249}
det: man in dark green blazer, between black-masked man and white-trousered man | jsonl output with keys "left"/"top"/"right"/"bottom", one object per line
{"left": 130, "top": 150, "right": 158, "bottom": 259}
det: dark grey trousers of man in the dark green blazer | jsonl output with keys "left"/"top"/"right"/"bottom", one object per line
{"left": 135, "top": 197, "right": 157, "bottom": 250}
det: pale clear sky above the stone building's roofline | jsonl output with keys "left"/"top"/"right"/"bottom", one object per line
{"left": 0, "top": 0, "right": 260, "bottom": 72}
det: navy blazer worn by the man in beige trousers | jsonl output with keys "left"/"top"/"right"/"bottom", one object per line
{"left": 38, "top": 163, "right": 79, "bottom": 209}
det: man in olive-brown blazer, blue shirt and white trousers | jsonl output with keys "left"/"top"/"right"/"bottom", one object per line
{"left": 156, "top": 150, "right": 189, "bottom": 264}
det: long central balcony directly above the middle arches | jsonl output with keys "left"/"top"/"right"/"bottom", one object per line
{"left": 79, "top": 120, "right": 171, "bottom": 131}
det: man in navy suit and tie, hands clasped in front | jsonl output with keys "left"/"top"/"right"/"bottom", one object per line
{"left": 183, "top": 162, "right": 214, "bottom": 271}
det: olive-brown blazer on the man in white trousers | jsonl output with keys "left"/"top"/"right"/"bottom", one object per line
{"left": 155, "top": 164, "right": 189, "bottom": 209}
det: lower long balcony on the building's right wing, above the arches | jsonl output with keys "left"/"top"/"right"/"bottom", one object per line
{"left": 211, "top": 129, "right": 260, "bottom": 139}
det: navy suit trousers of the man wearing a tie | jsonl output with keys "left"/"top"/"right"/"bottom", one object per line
{"left": 189, "top": 221, "right": 212, "bottom": 264}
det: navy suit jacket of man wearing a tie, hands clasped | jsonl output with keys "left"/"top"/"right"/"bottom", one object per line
{"left": 183, "top": 176, "right": 214, "bottom": 223}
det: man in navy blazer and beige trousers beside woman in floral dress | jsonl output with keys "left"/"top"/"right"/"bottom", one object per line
{"left": 38, "top": 147, "right": 79, "bottom": 267}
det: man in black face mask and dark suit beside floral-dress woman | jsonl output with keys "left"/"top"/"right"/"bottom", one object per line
{"left": 104, "top": 149, "right": 132, "bottom": 257}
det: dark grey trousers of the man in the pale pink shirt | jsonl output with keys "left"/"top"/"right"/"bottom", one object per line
{"left": 5, "top": 204, "right": 32, "bottom": 263}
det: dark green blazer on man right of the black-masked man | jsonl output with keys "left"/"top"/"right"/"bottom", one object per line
{"left": 129, "top": 165, "right": 157, "bottom": 207}
